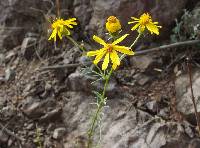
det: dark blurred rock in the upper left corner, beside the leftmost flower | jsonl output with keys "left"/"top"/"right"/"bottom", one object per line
{"left": 0, "top": 0, "right": 44, "bottom": 49}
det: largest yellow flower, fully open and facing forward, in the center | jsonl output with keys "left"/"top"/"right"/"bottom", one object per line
{"left": 87, "top": 34, "right": 134, "bottom": 70}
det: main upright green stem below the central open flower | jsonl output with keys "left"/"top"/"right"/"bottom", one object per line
{"left": 87, "top": 69, "right": 113, "bottom": 148}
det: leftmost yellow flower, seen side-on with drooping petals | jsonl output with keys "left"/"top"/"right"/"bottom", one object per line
{"left": 48, "top": 18, "right": 77, "bottom": 41}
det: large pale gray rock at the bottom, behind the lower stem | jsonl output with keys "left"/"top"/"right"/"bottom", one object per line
{"left": 62, "top": 92, "right": 196, "bottom": 148}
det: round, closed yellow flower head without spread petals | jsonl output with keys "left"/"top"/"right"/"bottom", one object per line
{"left": 106, "top": 16, "right": 121, "bottom": 33}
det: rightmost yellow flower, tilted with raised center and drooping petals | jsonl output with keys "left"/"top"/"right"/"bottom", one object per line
{"left": 128, "top": 13, "right": 161, "bottom": 35}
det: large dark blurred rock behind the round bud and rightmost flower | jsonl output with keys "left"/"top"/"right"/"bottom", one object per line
{"left": 85, "top": 0, "right": 197, "bottom": 37}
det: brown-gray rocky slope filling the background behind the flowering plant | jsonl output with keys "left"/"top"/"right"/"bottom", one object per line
{"left": 0, "top": 0, "right": 200, "bottom": 148}
